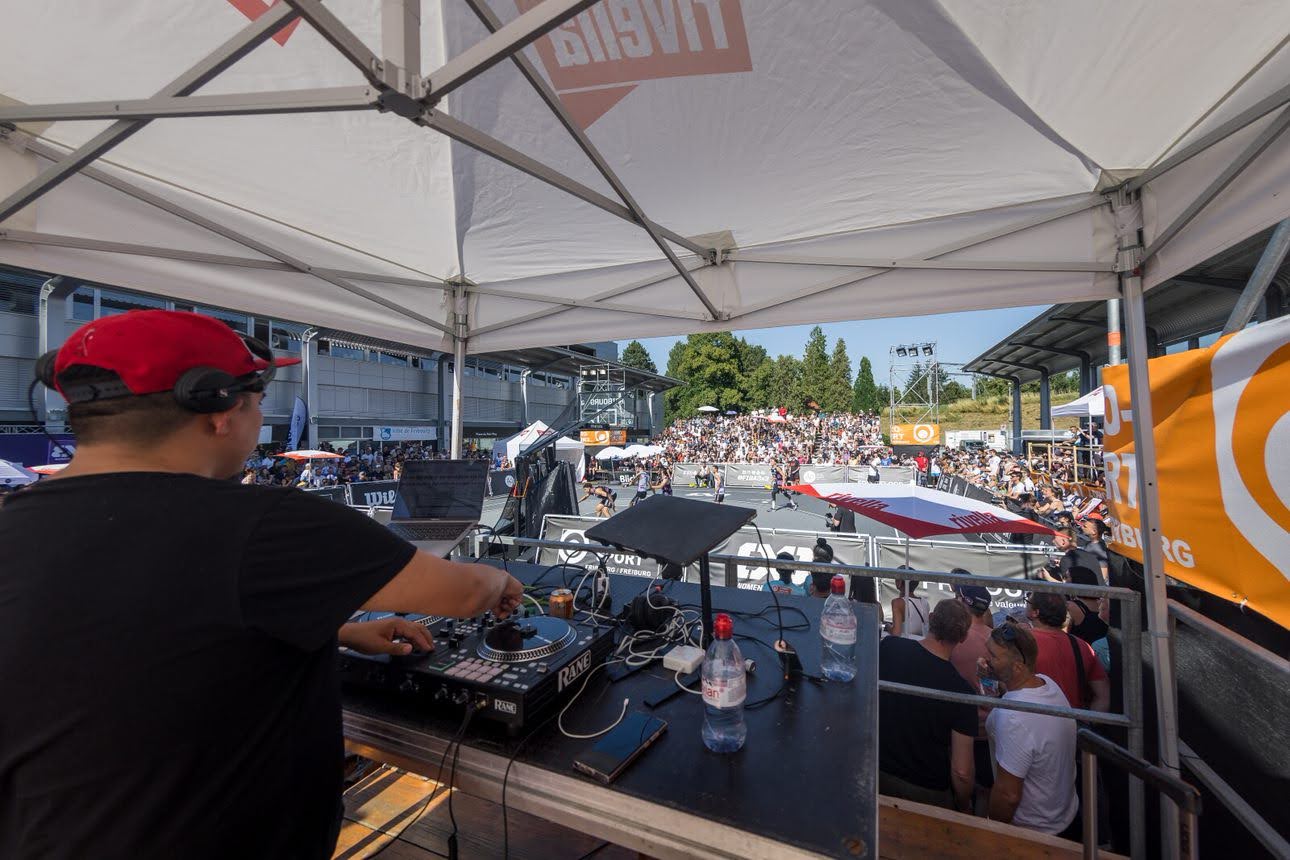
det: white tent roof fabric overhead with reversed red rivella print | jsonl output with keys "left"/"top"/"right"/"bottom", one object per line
{"left": 0, "top": 0, "right": 1290, "bottom": 352}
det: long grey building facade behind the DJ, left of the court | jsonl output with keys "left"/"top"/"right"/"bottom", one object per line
{"left": 0, "top": 267, "right": 672, "bottom": 456}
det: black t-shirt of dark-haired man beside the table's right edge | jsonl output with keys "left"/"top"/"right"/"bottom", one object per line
{"left": 878, "top": 636, "right": 977, "bottom": 790}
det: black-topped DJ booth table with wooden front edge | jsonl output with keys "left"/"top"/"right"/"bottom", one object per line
{"left": 343, "top": 563, "right": 878, "bottom": 860}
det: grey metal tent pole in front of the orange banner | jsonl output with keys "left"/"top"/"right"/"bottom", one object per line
{"left": 1117, "top": 193, "right": 1179, "bottom": 857}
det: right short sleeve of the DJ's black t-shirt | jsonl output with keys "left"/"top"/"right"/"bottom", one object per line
{"left": 239, "top": 490, "right": 417, "bottom": 650}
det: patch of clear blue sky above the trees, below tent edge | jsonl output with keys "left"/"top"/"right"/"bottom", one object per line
{"left": 618, "top": 306, "right": 1047, "bottom": 386}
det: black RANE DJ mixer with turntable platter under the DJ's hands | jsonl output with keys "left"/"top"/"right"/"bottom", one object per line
{"left": 339, "top": 612, "right": 614, "bottom": 732}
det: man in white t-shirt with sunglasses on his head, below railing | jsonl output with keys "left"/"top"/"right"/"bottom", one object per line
{"left": 986, "top": 623, "right": 1080, "bottom": 838}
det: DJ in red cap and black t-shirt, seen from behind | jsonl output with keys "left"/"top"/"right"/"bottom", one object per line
{"left": 0, "top": 311, "right": 521, "bottom": 859}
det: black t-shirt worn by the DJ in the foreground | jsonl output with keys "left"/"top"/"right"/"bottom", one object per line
{"left": 0, "top": 472, "right": 415, "bottom": 860}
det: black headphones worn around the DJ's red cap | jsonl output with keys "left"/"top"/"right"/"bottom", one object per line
{"left": 36, "top": 335, "right": 277, "bottom": 414}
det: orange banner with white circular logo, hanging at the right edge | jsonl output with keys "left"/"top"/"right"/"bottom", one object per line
{"left": 1102, "top": 317, "right": 1290, "bottom": 627}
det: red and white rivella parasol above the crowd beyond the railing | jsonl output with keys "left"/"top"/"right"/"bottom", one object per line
{"left": 788, "top": 484, "right": 1054, "bottom": 538}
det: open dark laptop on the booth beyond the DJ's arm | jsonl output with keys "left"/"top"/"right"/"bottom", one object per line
{"left": 386, "top": 460, "right": 488, "bottom": 556}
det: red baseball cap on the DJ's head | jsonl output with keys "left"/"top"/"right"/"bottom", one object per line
{"left": 54, "top": 311, "right": 301, "bottom": 395}
